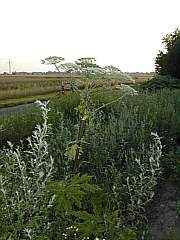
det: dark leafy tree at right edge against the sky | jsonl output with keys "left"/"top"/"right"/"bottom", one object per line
{"left": 155, "top": 29, "right": 180, "bottom": 78}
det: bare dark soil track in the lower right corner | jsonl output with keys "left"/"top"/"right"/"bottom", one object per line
{"left": 148, "top": 177, "right": 180, "bottom": 240}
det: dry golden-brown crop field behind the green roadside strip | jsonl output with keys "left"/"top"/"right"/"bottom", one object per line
{"left": 0, "top": 75, "right": 136, "bottom": 100}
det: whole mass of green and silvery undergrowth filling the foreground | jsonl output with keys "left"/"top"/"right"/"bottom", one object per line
{"left": 0, "top": 89, "right": 180, "bottom": 240}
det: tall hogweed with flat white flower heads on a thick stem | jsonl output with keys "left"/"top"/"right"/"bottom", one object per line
{"left": 42, "top": 57, "right": 105, "bottom": 173}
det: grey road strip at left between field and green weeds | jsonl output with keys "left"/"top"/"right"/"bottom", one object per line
{"left": 0, "top": 103, "right": 36, "bottom": 117}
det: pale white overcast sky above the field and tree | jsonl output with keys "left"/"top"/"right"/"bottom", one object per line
{"left": 0, "top": 0, "right": 180, "bottom": 72}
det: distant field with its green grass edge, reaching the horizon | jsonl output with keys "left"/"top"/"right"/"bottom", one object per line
{"left": 0, "top": 73, "right": 153, "bottom": 107}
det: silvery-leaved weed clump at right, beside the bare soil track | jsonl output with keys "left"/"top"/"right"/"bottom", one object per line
{"left": 113, "top": 133, "right": 162, "bottom": 226}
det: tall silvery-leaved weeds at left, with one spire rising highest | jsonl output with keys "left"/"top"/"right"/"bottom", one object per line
{"left": 0, "top": 101, "right": 53, "bottom": 239}
